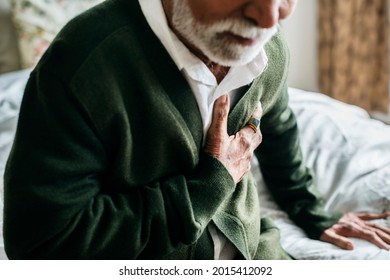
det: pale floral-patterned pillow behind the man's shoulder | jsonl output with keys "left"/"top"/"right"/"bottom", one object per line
{"left": 11, "top": 0, "right": 103, "bottom": 68}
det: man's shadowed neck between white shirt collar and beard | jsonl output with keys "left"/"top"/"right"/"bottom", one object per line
{"left": 162, "top": 0, "right": 230, "bottom": 84}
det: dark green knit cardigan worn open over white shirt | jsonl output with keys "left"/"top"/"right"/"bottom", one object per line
{"left": 4, "top": 0, "right": 340, "bottom": 259}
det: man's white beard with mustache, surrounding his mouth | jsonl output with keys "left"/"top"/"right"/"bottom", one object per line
{"left": 172, "top": 0, "right": 277, "bottom": 66}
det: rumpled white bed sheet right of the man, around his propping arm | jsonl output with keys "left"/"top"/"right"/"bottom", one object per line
{"left": 254, "top": 88, "right": 390, "bottom": 259}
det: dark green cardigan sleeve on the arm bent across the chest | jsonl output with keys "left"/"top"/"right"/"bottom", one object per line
{"left": 4, "top": 73, "right": 235, "bottom": 259}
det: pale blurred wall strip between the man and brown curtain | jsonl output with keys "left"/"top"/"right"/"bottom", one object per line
{"left": 282, "top": 0, "right": 390, "bottom": 114}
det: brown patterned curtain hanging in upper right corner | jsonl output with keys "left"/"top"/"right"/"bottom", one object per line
{"left": 318, "top": 0, "right": 389, "bottom": 112}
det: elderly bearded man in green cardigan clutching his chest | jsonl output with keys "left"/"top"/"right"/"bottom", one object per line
{"left": 4, "top": 0, "right": 389, "bottom": 259}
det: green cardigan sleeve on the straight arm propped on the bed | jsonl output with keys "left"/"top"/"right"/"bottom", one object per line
{"left": 256, "top": 82, "right": 341, "bottom": 239}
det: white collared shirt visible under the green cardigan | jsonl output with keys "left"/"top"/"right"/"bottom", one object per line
{"left": 138, "top": 0, "right": 268, "bottom": 259}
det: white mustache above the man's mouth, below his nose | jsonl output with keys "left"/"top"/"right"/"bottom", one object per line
{"left": 203, "top": 18, "right": 276, "bottom": 39}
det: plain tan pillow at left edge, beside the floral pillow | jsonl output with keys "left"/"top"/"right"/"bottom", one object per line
{"left": 0, "top": 0, "right": 20, "bottom": 73}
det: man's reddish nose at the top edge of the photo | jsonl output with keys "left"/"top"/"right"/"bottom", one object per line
{"left": 243, "top": 0, "right": 281, "bottom": 28}
